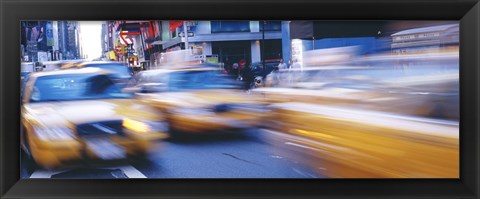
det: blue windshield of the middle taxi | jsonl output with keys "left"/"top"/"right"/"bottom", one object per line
{"left": 168, "top": 70, "right": 241, "bottom": 91}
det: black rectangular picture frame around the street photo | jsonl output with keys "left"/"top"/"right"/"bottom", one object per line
{"left": 0, "top": 0, "right": 480, "bottom": 198}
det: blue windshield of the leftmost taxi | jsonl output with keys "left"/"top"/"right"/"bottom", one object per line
{"left": 30, "top": 74, "right": 131, "bottom": 102}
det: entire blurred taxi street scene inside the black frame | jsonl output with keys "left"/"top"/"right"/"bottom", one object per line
{"left": 20, "top": 20, "right": 460, "bottom": 179}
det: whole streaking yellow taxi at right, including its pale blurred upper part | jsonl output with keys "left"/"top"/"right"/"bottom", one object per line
{"left": 252, "top": 66, "right": 459, "bottom": 178}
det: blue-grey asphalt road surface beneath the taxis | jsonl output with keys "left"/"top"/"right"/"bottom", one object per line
{"left": 21, "top": 130, "right": 322, "bottom": 179}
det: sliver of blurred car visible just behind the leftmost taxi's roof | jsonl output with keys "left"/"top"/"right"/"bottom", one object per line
{"left": 62, "top": 61, "right": 133, "bottom": 88}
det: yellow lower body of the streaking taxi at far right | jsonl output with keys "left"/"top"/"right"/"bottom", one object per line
{"left": 264, "top": 102, "right": 459, "bottom": 178}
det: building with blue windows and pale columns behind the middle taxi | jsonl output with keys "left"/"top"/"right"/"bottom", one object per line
{"left": 150, "top": 21, "right": 282, "bottom": 64}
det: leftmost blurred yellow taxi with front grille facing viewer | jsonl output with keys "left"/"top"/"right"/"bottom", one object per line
{"left": 21, "top": 68, "right": 168, "bottom": 169}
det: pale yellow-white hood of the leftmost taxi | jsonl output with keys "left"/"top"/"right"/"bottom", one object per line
{"left": 24, "top": 99, "right": 162, "bottom": 125}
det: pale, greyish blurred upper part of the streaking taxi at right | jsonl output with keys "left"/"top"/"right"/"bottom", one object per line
{"left": 252, "top": 66, "right": 460, "bottom": 120}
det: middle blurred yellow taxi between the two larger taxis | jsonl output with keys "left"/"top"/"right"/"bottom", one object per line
{"left": 127, "top": 66, "right": 267, "bottom": 133}
